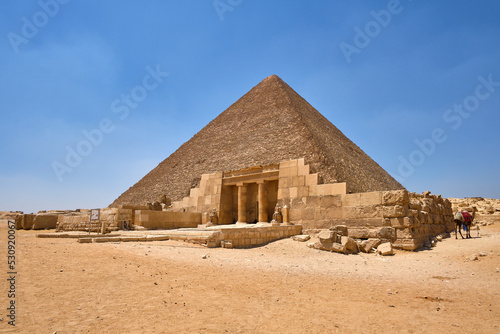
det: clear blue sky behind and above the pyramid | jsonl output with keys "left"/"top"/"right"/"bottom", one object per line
{"left": 0, "top": 0, "right": 500, "bottom": 212}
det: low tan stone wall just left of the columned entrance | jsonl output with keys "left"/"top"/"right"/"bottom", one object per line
{"left": 135, "top": 210, "right": 202, "bottom": 230}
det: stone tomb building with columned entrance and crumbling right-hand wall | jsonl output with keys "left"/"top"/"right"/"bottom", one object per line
{"left": 172, "top": 159, "right": 453, "bottom": 250}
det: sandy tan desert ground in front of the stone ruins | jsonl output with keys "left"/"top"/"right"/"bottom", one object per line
{"left": 0, "top": 221, "right": 500, "bottom": 333}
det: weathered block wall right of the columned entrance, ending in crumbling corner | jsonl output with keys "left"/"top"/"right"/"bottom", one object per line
{"left": 282, "top": 190, "right": 454, "bottom": 250}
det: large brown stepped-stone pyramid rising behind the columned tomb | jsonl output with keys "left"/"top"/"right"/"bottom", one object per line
{"left": 112, "top": 75, "right": 404, "bottom": 206}
